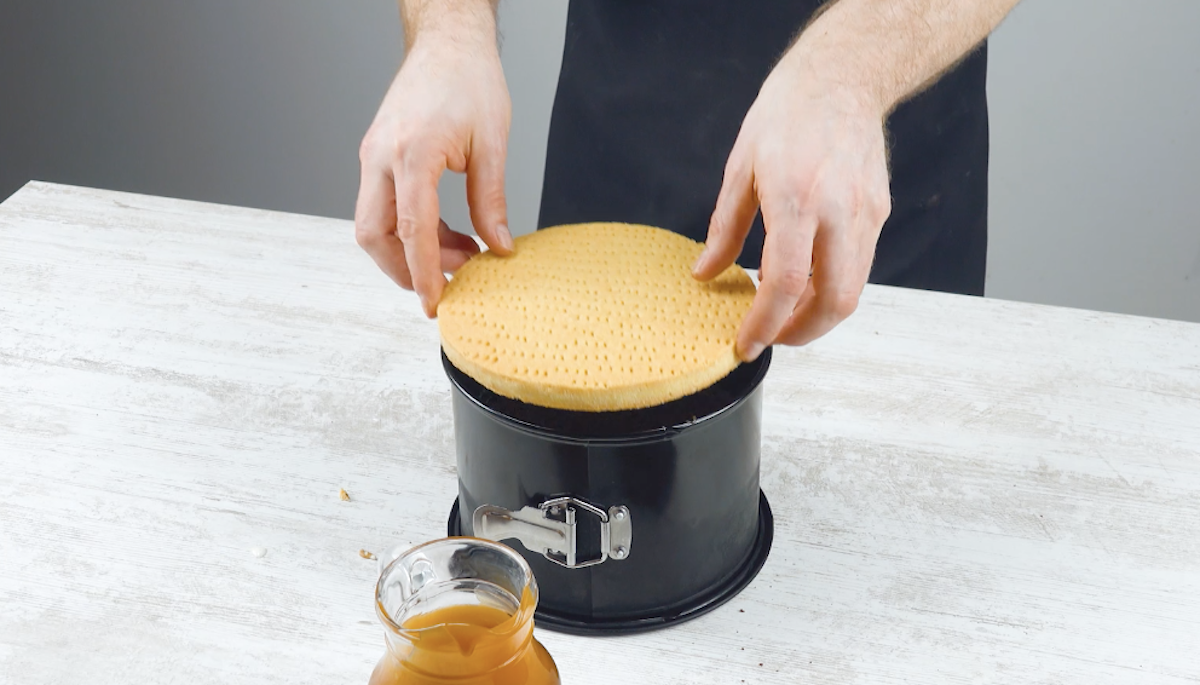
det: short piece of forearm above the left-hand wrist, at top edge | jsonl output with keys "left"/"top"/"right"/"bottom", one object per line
{"left": 400, "top": 0, "right": 499, "bottom": 53}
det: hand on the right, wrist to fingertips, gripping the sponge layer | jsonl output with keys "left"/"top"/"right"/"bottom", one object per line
{"left": 694, "top": 49, "right": 892, "bottom": 361}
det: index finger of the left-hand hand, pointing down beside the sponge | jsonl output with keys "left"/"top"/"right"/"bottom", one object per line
{"left": 392, "top": 160, "right": 446, "bottom": 318}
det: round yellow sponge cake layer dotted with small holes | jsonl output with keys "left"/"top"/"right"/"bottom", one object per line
{"left": 438, "top": 223, "right": 755, "bottom": 411}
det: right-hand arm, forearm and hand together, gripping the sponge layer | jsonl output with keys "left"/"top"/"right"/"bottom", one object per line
{"left": 694, "top": 0, "right": 1018, "bottom": 361}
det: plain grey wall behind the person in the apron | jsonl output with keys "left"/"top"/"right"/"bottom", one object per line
{"left": 0, "top": 0, "right": 1200, "bottom": 322}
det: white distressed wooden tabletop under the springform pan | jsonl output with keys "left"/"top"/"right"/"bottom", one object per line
{"left": 0, "top": 184, "right": 1200, "bottom": 685}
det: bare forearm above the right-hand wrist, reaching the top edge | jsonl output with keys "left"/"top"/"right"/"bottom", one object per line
{"left": 780, "top": 0, "right": 1019, "bottom": 115}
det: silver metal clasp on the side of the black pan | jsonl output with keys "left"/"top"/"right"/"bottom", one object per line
{"left": 472, "top": 497, "right": 634, "bottom": 569}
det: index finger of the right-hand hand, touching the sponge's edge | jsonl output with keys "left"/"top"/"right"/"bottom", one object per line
{"left": 738, "top": 202, "right": 817, "bottom": 361}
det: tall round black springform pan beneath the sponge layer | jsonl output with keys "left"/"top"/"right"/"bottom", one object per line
{"left": 442, "top": 348, "right": 773, "bottom": 635}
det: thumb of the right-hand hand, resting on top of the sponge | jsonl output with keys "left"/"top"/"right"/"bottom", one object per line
{"left": 691, "top": 145, "right": 758, "bottom": 281}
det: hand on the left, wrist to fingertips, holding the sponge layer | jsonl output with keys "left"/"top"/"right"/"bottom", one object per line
{"left": 354, "top": 35, "right": 512, "bottom": 318}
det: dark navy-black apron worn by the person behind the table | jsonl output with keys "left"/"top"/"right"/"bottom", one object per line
{"left": 538, "top": 0, "right": 988, "bottom": 295}
